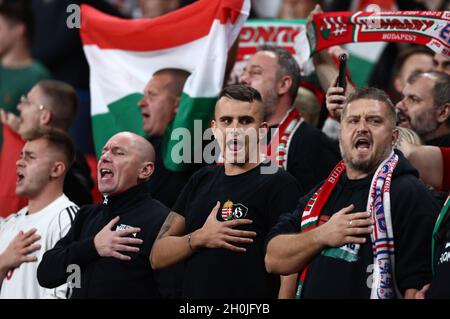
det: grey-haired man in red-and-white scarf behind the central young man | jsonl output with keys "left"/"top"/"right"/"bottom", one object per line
{"left": 239, "top": 46, "right": 340, "bottom": 191}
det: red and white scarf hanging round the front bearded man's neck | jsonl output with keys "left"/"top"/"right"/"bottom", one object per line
{"left": 296, "top": 152, "right": 400, "bottom": 299}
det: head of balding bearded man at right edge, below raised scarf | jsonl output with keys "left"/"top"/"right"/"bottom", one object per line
{"left": 397, "top": 71, "right": 450, "bottom": 147}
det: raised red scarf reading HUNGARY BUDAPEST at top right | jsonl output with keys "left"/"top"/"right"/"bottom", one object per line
{"left": 295, "top": 11, "right": 450, "bottom": 63}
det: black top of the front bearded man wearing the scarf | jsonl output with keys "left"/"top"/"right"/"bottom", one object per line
{"left": 268, "top": 156, "right": 439, "bottom": 299}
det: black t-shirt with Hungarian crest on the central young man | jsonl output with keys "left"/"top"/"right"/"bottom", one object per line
{"left": 173, "top": 164, "right": 300, "bottom": 298}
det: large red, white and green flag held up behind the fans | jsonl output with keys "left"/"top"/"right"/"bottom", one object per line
{"left": 81, "top": 0, "right": 250, "bottom": 171}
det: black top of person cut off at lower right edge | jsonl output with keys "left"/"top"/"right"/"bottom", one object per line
{"left": 427, "top": 199, "right": 450, "bottom": 299}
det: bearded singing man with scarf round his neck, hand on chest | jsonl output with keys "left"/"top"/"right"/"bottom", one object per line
{"left": 266, "top": 88, "right": 438, "bottom": 299}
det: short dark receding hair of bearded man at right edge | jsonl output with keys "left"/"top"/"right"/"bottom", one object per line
{"left": 408, "top": 71, "right": 450, "bottom": 125}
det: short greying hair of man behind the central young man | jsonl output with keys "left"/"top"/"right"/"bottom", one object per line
{"left": 258, "top": 45, "right": 301, "bottom": 103}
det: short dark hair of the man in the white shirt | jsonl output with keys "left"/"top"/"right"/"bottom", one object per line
{"left": 27, "top": 127, "right": 75, "bottom": 169}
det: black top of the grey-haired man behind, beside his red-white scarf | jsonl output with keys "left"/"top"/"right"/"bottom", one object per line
{"left": 287, "top": 122, "right": 341, "bottom": 192}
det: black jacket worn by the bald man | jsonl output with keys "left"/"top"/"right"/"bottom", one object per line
{"left": 38, "top": 184, "right": 169, "bottom": 298}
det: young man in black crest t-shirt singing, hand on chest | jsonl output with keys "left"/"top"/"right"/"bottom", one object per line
{"left": 150, "top": 85, "right": 300, "bottom": 298}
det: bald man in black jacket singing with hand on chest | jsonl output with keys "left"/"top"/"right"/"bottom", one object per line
{"left": 38, "top": 132, "right": 169, "bottom": 298}
